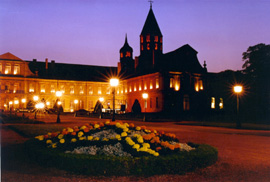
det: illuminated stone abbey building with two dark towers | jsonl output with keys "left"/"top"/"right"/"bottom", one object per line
{"left": 0, "top": 7, "right": 211, "bottom": 116}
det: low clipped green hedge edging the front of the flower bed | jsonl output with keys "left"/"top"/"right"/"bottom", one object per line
{"left": 25, "top": 139, "right": 218, "bottom": 176}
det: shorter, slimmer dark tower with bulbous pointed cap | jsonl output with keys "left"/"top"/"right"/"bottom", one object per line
{"left": 119, "top": 35, "right": 134, "bottom": 73}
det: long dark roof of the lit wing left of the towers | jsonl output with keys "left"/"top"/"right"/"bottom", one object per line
{"left": 29, "top": 61, "right": 117, "bottom": 82}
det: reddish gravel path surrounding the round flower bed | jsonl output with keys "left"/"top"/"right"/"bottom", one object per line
{"left": 0, "top": 118, "right": 270, "bottom": 182}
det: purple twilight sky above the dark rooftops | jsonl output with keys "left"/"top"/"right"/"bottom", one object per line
{"left": 0, "top": 0, "right": 270, "bottom": 72}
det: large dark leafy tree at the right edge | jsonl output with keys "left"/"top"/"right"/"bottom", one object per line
{"left": 242, "top": 44, "right": 270, "bottom": 120}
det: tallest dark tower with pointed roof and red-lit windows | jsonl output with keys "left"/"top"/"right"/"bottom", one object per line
{"left": 139, "top": 4, "right": 163, "bottom": 72}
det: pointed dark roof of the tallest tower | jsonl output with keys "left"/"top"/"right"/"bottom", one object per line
{"left": 141, "top": 7, "right": 162, "bottom": 36}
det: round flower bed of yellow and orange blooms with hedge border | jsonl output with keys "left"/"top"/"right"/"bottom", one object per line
{"left": 25, "top": 122, "right": 217, "bottom": 175}
